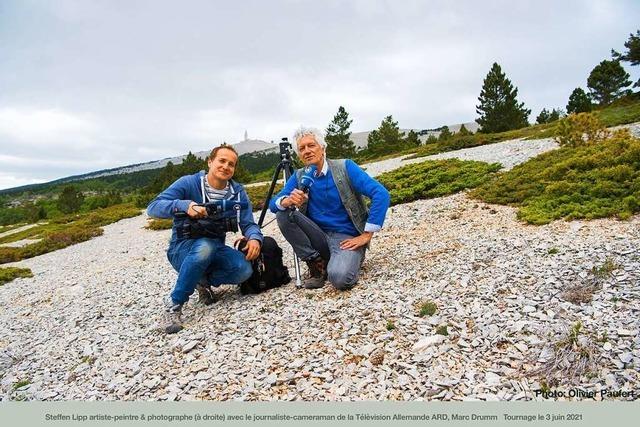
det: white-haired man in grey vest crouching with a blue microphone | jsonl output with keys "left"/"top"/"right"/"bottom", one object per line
{"left": 269, "top": 127, "right": 390, "bottom": 290}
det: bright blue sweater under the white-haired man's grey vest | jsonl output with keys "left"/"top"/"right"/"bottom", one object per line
{"left": 269, "top": 159, "right": 391, "bottom": 236}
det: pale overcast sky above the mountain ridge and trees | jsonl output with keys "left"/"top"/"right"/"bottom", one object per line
{"left": 0, "top": 0, "right": 640, "bottom": 189}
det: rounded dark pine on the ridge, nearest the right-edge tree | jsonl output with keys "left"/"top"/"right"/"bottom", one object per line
{"left": 587, "top": 59, "right": 631, "bottom": 105}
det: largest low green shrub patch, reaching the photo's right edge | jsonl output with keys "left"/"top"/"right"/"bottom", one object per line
{"left": 471, "top": 134, "right": 640, "bottom": 224}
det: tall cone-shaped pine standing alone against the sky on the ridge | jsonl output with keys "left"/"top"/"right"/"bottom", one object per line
{"left": 476, "top": 62, "right": 531, "bottom": 133}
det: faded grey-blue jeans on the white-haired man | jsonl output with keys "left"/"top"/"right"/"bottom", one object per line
{"left": 276, "top": 210, "right": 365, "bottom": 290}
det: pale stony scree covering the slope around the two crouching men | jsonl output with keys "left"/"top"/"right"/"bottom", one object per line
{"left": 0, "top": 128, "right": 640, "bottom": 400}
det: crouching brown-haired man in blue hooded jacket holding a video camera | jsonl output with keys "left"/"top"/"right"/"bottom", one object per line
{"left": 147, "top": 144, "right": 262, "bottom": 333}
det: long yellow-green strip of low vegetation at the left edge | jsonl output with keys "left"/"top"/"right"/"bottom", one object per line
{"left": 0, "top": 203, "right": 141, "bottom": 264}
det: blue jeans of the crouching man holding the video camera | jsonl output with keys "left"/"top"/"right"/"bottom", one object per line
{"left": 167, "top": 237, "right": 253, "bottom": 304}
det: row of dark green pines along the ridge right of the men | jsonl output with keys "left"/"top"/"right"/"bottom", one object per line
{"left": 326, "top": 30, "right": 640, "bottom": 159}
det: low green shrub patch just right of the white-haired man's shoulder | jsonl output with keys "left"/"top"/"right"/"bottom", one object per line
{"left": 377, "top": 159, "right": 501, "bottom": 205}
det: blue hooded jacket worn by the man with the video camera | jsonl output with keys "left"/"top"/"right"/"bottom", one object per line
{"left": 147, "top": 171, "right": 262, "bottom": 243}
